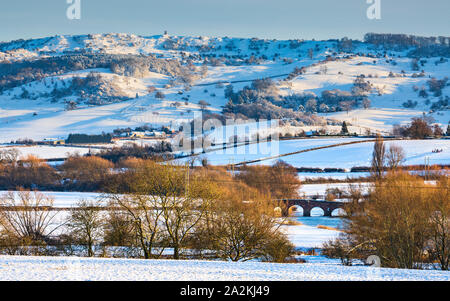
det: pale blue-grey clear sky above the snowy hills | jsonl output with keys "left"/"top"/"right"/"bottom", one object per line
{"left": 0, "top": 0, "right": 450, "bottom": 41}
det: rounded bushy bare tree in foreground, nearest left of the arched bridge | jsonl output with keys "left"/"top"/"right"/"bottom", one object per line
{"left": 200, "top": 194, "right": 292, "bottom": 262}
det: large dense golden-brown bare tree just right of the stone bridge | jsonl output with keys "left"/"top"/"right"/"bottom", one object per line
{"left": 345, "top": 172, "right": 432, "bottom": 269}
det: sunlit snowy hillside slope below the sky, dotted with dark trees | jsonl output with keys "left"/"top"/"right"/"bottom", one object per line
{"left": 0, "top": 34, "right": 450, "bottom": 142}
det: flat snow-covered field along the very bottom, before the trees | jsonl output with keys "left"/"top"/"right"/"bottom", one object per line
{"left": 0, "top": 256, "right": 450, "bottom": 281}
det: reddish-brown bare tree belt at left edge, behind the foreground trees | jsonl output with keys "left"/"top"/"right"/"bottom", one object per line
{"left": 0, "top": 143, "right": 170, "bottom": 191}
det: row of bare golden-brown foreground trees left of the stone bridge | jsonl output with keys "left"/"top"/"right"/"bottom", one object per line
{"left": 0, "top": 160, "right": 293, "bottom": 262}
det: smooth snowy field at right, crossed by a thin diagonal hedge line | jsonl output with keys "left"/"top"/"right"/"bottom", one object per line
{"left": 180, "top": 138, "right": 450, "bottom": 168}
